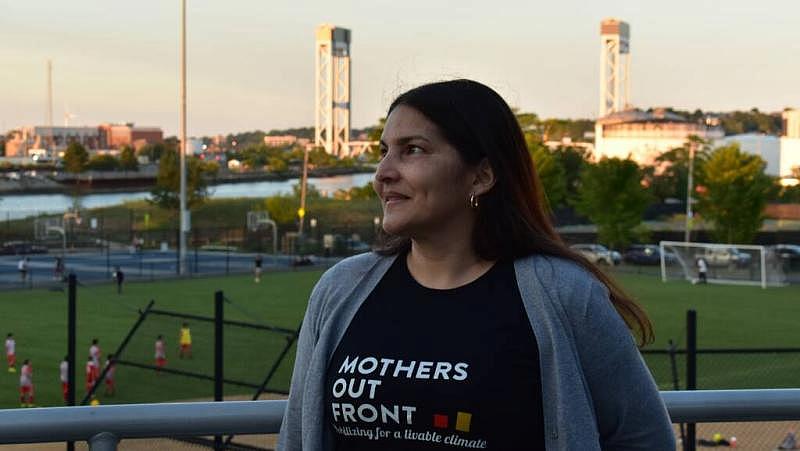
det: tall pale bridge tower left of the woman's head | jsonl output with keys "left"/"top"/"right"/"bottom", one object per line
{"left": 314, "top": 24, "right": 350, "bottom": 157}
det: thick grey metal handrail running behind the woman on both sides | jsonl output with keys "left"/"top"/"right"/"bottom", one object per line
{"left": 0, "top": 389, "right": 800, "bottom": 451}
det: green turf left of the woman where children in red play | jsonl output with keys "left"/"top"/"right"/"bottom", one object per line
{"left": 0, "top": 272, "right": 320, "bottom": 408}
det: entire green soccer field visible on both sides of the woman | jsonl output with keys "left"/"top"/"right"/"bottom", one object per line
{"left": 0, "top": 271, "right": 800, "bottom": 408}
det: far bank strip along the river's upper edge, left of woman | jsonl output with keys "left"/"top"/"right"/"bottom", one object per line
{"left": 0, "top": 166, "right": 375, "bottom": 196}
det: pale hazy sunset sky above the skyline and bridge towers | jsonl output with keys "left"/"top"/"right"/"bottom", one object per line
{"left": 0, "top": 0, "right": 800, "bottom": 136}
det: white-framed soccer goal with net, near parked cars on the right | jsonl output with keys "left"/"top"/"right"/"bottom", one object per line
{"left": 659, "top": 241, "right": 786, "bottom": 288}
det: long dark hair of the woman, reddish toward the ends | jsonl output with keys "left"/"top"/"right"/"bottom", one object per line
{"left": 377, "top": 80, "right": 653, "bottom": 345}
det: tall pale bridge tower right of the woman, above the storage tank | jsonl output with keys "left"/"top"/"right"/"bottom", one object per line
{"left": 598, "top": 19, "right": 631, "bottom": 117}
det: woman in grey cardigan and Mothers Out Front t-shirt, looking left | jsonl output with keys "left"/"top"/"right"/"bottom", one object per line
{"left": 278, "top": 80, "right": 675, "bottom": 450}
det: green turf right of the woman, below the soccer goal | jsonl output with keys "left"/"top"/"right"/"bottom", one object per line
{"left": 619, "top": 274, "right": 800, "bottom": 389}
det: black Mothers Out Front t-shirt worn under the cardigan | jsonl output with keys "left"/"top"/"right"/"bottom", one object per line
{"left": 325, "top": 254, "right": 544, "bottom": 451}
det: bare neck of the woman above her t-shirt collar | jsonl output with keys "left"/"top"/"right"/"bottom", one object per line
{"left": 406, "top": 239, "right": 494, "bottom": 290}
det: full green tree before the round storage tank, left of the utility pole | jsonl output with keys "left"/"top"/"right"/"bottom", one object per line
{"left": 575, "top": 158, "right": 651, "bottom": 248}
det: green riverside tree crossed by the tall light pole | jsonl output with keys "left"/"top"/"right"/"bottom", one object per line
{"left": 150, "top": 150, "right": 219, "bottom": 211}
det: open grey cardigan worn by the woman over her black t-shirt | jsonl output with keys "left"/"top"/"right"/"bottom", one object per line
{"left": 278, "top": 253, "right": 675, "bottom": 451}
